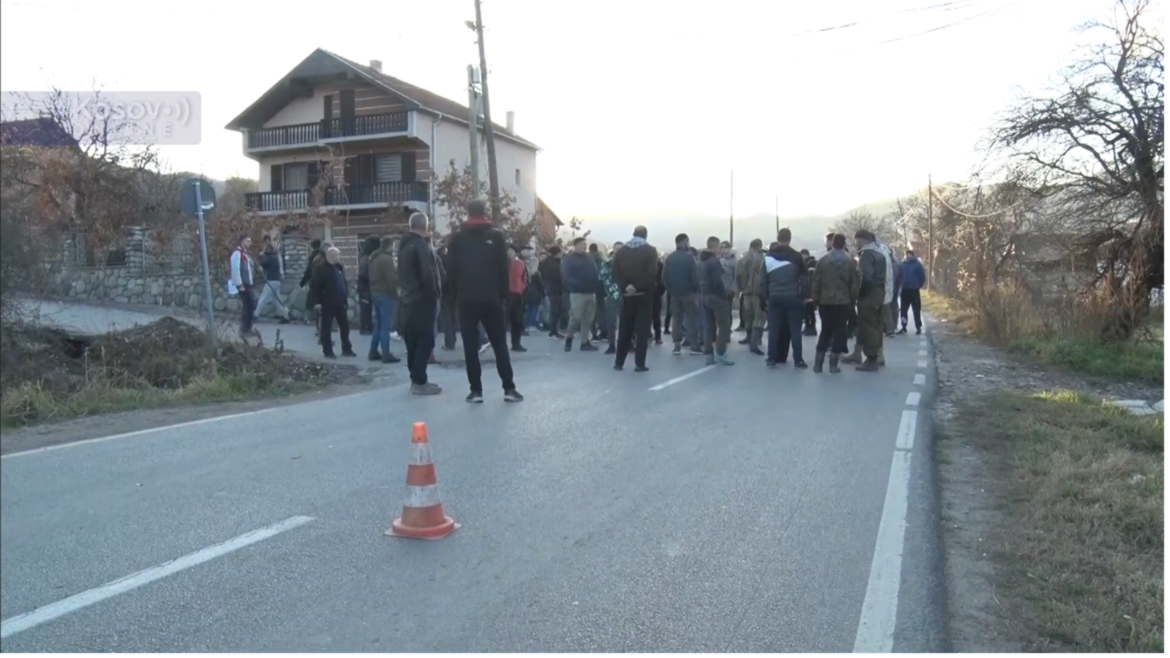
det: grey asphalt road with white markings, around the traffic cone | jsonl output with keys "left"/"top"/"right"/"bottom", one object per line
{"left": 0, "top": 325, "right": 948, "bottom": 654}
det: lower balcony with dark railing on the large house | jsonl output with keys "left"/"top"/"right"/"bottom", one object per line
{"left": 245, "top": 181, "right": 431, "bottom": 214}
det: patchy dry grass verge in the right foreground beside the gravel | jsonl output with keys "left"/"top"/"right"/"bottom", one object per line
{"left": 957, "top": 392, "right": 1165, "bottom": 654}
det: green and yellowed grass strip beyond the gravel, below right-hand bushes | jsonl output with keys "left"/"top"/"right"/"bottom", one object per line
{"left": 923, "top": 293, "right": 1166, "bottom": 386}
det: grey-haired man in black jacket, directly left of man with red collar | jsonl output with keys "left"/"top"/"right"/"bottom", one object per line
{"left": 398, "top": 212, "right": 442, "bottom": 396}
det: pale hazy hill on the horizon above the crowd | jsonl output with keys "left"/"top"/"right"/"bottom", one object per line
{"left": 585, "top": 190, "right": 904, "bottom": 251}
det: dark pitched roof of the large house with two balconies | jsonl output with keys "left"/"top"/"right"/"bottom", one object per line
{"left": 226, "top": 48, "right": 541, "bottom": 151}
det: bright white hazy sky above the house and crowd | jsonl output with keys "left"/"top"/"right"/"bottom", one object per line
{"left": 0, "top": 0, "right": 1113, "bottom": 218}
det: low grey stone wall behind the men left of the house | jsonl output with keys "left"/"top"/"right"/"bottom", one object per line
{"left": 50, "top": 229, "right": 379, "bottom": 321}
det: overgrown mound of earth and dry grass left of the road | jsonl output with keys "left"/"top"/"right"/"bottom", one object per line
{"left": 0, "top": 317, "right": 356, "bottom": 426}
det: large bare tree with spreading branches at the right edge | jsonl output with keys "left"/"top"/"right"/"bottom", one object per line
{"left": 990, "top": 0, "right": 1165, "bottom": 338}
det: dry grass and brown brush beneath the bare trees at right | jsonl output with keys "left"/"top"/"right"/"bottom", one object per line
{"left": 923, "top": 286, "right": 1165, "bottom": 385}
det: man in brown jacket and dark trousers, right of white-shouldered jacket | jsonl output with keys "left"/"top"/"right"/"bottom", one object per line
{"left": 812, "top": 235, "right": 861, "bottom": 373}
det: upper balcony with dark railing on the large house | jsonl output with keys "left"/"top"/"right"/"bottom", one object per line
{"left": 246, "top": 112, "right": 411, "bottom": 153}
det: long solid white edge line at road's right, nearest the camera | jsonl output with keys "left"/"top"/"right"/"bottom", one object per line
{"left": 853, "top": 411, "right": 918, "bottom": 656}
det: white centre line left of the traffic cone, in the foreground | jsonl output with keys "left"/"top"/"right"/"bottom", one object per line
{"left": 0, "top": 516, "right": 314, "bottom": 638}
